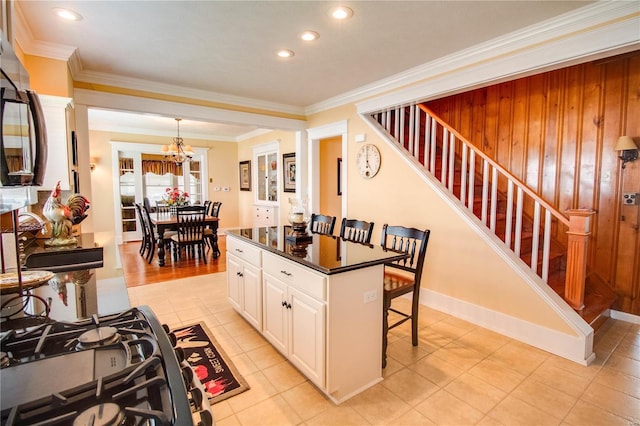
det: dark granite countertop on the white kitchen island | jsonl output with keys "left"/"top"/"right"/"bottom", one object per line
{"left": 226, "top": 226, "right": 407, "bottom": 275}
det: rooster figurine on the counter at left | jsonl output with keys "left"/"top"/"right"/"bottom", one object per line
{"left": 42, "top": 181, "right": 89, "bottom": 246}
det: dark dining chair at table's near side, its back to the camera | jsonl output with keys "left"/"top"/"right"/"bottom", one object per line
{"left": 171, "top": 206, "right": 207, "bottom": 263}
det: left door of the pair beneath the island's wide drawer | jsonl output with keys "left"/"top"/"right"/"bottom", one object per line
{"left": 262, "top": 274, "right": 289, "bottom": 356}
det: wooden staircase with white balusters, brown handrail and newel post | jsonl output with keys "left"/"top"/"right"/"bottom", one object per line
{"left": 365, "top": 104, "right": 615, "bottom": 328}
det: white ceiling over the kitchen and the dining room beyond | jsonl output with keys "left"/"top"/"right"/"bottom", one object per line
{"left": 16, "top": 0, "right": 591, "bottom": 140}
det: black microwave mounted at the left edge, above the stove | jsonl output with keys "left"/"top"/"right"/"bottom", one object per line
{"left": 0, "top": 33, "right": 47, "bottom": 187}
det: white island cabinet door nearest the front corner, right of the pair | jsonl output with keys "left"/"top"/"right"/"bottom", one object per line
{"left": 288, "top": 287, "right": 325, "bottom": 388}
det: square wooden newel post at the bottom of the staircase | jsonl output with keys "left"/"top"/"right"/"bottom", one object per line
{"left": 564, "top": 209, "right": 595, "bottom": 310}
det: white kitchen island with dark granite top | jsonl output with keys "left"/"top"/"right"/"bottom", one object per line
{"left": 227, "top": 226, "right": 406, "bottom": 404}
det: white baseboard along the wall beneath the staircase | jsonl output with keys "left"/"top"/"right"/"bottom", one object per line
{"left": 420, "top": 288, "right": 595, "bottom": 365}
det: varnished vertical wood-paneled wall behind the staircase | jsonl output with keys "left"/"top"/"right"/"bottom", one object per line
{"left": 427, "top": 51, "right": 640, "bottom": 315}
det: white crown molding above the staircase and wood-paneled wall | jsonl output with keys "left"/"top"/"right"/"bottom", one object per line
{"left": 312, "top": 2, "right": 640, "bottom": 115}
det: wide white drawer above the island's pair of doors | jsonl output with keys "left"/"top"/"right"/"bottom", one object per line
{"left": 262, "top": 252, "right": 327, "bottom": 301}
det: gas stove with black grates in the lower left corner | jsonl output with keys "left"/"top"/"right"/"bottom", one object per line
{"left": 0, "top": 306, "right": 213, "bottom": 426}
